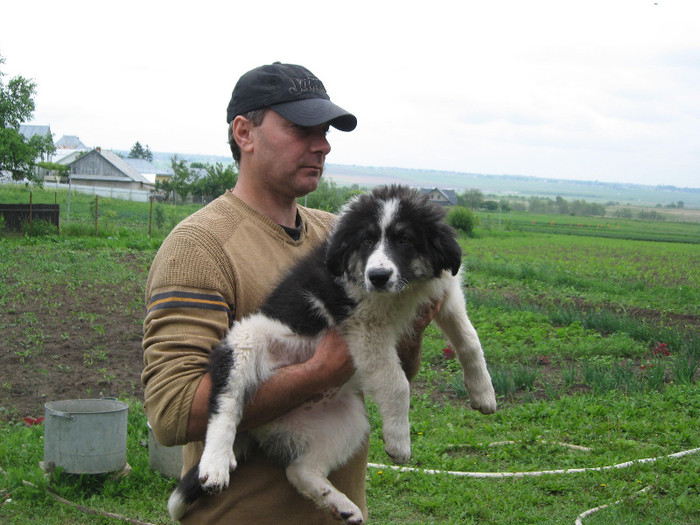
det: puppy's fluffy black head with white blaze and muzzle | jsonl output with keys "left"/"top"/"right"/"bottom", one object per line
{"left": 326, "top": 186, "right": 462, "bottom": 293}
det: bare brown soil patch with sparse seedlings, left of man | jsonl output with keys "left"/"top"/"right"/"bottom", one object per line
{"left": 0, "top": 275, "right": 145, "bottom": 421}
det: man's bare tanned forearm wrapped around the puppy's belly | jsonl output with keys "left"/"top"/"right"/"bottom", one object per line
{"left": 187, "top": 330, "right": 355, "bottom": 441}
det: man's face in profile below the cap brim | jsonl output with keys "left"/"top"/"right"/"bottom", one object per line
{"left": 252, "top": 111, "right": 331, "bottom": 198}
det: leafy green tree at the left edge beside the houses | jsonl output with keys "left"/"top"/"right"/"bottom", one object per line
{"left": 0, "top": 55, "right": 44, "bottom": 184}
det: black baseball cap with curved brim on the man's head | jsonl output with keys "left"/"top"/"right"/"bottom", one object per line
{"left": 226, "top": 62, "right": 357, "bottom": 131}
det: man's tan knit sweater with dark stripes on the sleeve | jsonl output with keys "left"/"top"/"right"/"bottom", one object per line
{"left": 142, "top": 192, "right": 367, "bottom": 525}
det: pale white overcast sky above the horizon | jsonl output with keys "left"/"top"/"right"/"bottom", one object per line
{"left": 0, "top": 0, "right": 700, "bottom": 187}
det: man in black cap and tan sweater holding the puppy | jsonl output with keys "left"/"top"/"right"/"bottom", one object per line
{"left": 142, "top": 62, "right": 429, "bottom": 524}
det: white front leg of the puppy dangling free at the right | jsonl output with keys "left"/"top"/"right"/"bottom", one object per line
{"left": 435, "top": 277, "right": 496, "bottom": 414}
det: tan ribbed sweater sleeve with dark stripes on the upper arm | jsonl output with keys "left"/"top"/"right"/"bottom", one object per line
{"left": 141, "top": 227, "right": 234, "bottom": 446}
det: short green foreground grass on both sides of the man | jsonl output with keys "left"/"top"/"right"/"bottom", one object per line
{"left": 0, "top": 385, "right": 700, "bottom": 525}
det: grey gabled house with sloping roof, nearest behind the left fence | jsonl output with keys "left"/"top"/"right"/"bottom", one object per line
{"left": 58, "top": 148, "right": 155, "bottom": 190}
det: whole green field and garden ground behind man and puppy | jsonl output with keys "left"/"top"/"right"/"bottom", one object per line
{"left": 0, "top": 186, "right": 700, "bottom": 525}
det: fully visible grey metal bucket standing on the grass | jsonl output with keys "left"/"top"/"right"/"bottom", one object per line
{"left": 44, "top": 398, "right": 129, "bottom": 474}
